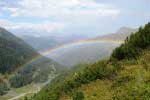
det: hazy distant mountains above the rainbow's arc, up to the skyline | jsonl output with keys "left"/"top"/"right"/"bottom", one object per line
{"left": 19, "top": 27, "right": 137, "bottom": 52}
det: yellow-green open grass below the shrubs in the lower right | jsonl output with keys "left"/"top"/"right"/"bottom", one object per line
{"left": 60, "top": 51, "right": 150, "bottom": 100}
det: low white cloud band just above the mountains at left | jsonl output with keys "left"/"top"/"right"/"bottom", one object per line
{"left": 0, "top": 19, "right": 64, "bottom": 35}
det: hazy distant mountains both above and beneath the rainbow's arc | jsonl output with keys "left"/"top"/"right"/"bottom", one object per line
{"left": 17, "top": 27, "right": 137, "bottom": 67}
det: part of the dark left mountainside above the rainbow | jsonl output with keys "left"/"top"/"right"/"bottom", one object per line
{"left": 0, "top": 28, "right": 38, "bottom": 73}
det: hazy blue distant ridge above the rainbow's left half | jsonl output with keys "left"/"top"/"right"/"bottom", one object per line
{"left": 19, "top": 34, "right": 87, "bottom": 52}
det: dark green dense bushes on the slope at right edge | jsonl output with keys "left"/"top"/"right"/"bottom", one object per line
{"left": 112, "top": 23, "right": 150, "bottom": 60}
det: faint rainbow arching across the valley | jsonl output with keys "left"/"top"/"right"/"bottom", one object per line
{"left": 20, "top": 40, "right": 123, "bottom": 66}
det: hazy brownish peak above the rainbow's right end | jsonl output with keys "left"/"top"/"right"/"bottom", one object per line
{"left": 95, "top": 27, "right": 137, "bottom": 41}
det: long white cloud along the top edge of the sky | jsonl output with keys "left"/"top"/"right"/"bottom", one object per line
{"left": 7, "top": 0, "right": 119, "bottom": 17}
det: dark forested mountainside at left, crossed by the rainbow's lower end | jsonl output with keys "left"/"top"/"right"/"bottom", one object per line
{"left": 0, "top": 28, "right": 62, "bottom": 95}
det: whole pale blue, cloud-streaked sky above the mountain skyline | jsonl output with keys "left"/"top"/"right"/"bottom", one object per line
{"left": 0, "top": 0, "right": 150, "bottom": 36}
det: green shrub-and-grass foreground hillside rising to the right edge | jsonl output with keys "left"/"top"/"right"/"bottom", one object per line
{"left": 29, "top": 23, "right": 150, "bottom": 100}
